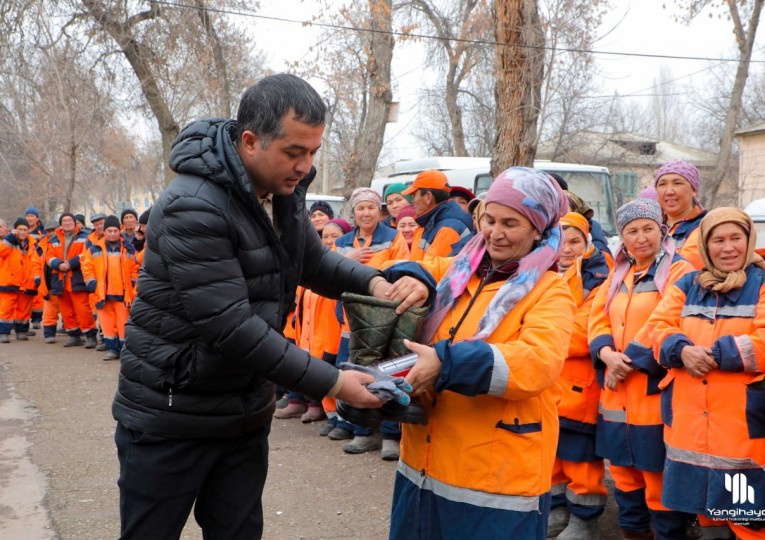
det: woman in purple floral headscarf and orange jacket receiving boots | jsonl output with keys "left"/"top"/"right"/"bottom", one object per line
{"left": 390, "top": 167, "right": 575, "bottom": 540}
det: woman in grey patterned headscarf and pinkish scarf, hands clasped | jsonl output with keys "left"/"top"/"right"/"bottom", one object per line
{"left": 588, "top": 199, "right": 693, "bottom": 539}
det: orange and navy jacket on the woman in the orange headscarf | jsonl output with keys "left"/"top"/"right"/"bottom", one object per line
{"left": 558, "top": 246, "right": 609, "bottom": 462}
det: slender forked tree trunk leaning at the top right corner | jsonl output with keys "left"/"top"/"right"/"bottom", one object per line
{"left": 701, "top": 0, "right": 765, "bottom": 208}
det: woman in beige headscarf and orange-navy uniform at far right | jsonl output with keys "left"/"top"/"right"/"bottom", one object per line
{"left": 648, "top": 208, "right": 765, "bottom": 539}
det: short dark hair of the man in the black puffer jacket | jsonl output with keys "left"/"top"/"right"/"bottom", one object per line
{"left": 236, "top": 73, "right": 327, "bottom": 149}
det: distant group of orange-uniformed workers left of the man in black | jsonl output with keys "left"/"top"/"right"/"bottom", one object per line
{"left": 0, "top": 207, "right": 148, "bottom": 360}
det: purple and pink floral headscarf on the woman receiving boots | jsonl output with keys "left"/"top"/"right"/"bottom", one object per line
{"left": 422, "top": 167, "right": 568, "bottom": 342}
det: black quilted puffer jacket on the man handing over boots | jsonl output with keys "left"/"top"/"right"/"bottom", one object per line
{"left": 112, "top": 120, "right": 379, "bottom": 438}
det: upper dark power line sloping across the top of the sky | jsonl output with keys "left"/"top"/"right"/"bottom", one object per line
{"left": 154, "top": 0, "right": 765, "bottom": 64}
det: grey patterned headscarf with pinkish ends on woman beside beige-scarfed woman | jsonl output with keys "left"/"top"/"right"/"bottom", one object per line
{"left": 606, "top": 199, "right": 675, "bottom": 313}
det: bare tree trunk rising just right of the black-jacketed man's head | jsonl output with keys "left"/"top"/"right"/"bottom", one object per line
{"left": 344, "top": 0, "right": 394, "bottom": 198}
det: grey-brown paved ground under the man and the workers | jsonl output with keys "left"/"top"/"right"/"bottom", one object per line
{"left": 0, "top": 336, "right": 618, "bottom": 540}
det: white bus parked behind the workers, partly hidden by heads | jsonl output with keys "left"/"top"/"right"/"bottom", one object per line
{"left": 372, "top": 157, "right": 618, "bottom": 239}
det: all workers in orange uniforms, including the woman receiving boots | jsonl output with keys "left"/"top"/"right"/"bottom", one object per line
{"left": 0, "top": 154, "right": 765, "bottom": 540}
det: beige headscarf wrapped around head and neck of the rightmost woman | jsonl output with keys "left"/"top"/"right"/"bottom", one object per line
{"left": 698, "top": 207, "right": 765, "bottom": 293}
